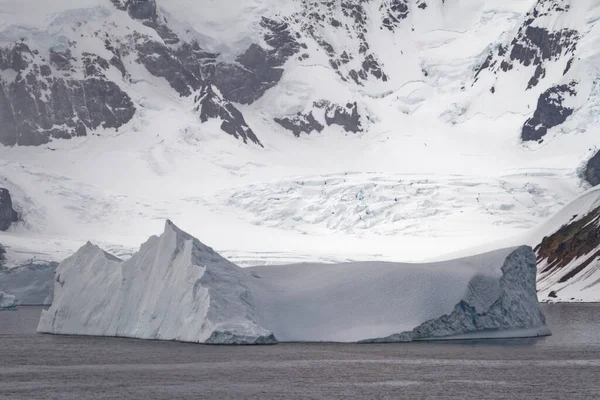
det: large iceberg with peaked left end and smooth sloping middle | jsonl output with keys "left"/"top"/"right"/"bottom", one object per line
{"left": 38, "top": 221, "right": 550, "bottom": 344}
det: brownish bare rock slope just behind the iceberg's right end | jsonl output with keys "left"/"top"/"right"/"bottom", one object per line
{"left": 535, "top": 203, "right": 600, "bottom": 283}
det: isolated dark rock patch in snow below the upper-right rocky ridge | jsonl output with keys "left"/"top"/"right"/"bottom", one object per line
{"left": 521, "top": 81, "right": 577, "bottom": 141}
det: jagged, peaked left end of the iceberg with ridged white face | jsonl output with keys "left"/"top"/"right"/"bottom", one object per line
{"left": 38, "top": 221, "right": 274, "bottom": 344}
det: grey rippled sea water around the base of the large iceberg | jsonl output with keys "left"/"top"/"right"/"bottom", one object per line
{"left": 0, "top": 304, "right": 600, "bottom": 400}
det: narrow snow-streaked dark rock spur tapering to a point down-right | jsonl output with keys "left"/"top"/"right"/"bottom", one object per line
{"left": 194, "top": 83, "right": 262, "bottom": 147}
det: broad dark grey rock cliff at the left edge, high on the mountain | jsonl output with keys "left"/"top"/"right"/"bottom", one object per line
{"left": 0, "top": 42, "right": 135, "bottom": 146}
